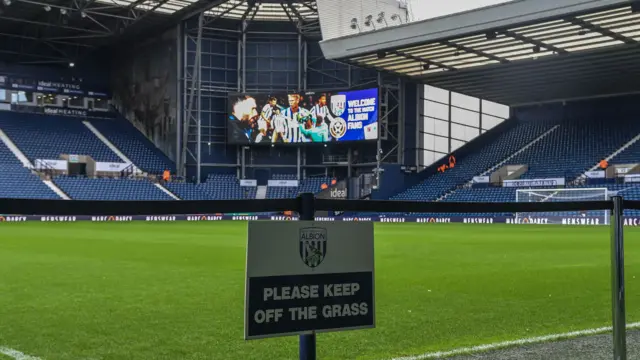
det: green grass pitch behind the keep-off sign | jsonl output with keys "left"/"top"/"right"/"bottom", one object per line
{"left": 0, "top": 222, "right": 640, "bottom": 360}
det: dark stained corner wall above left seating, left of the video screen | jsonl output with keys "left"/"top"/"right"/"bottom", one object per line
{"left": 111, "top": 30, "right": 178, "bottom": 161}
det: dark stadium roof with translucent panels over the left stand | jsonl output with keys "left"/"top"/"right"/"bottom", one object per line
{"left": 0, "top": 0, "right": 318, "bottom": 63}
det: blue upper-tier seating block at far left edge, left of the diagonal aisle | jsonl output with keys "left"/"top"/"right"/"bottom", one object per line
{"left": 0, "top": 112, "right": 122, "bottom": 162}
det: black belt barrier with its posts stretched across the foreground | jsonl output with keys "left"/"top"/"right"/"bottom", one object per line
{"left": 0, "top": 194, "right": 640, "bottom": 360}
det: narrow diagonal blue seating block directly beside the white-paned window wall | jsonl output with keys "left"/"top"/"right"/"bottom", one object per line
{"left": 392, "top": 122, "right": 557, "bottom": 200}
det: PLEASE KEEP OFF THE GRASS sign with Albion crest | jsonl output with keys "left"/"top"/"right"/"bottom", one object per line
{"left": 244, "top": 221, "right": 375, "bottom": 339}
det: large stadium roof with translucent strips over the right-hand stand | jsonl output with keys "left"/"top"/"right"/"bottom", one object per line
{"left": 321, "top": 0, "right": 640, "bottom": 105}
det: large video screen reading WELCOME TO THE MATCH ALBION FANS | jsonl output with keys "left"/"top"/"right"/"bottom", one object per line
{"left": 227, "top": 88, "right": 378, "bottom": 145}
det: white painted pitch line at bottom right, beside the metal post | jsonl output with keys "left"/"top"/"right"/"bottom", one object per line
{"left": 391, "top": 322, "right": 640, "bottom": 360}
